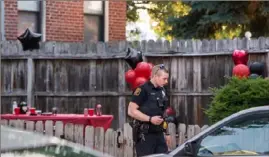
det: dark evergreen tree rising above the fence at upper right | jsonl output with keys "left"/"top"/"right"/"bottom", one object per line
{"left": 166, "top": 1, "right": 269, "bottom": 39}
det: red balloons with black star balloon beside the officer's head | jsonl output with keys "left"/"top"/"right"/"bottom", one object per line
{"left": 125, "top": 48, "right": 154, "bottom": 90}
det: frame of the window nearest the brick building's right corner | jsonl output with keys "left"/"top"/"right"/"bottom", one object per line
{"left": 83, "top": 1, "right": 106, "bottom": 42}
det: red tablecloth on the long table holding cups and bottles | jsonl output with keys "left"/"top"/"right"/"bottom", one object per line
{"left": 1, "top": 114, "right": 113, "bottom": 130}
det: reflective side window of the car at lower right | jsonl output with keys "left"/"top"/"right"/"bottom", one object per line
{"left": 197, "top": 112, "right": 269, "bottom": 156}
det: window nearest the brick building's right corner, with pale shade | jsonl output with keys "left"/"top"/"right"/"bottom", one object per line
{"left": 84, "top": 1, "right": 105, "bottom": 42}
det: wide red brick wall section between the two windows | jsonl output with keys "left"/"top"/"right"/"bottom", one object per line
{"left": 46, "top": 0, "right": 84, "bottom": 41}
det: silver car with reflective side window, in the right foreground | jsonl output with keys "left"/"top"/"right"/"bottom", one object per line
{"left": 144, "top": 105, "right": 269, "bottom": 157}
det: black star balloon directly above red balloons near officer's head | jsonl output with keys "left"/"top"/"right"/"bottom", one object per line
{"left": 124, "top": 48, "right": 143, "bottom": 69}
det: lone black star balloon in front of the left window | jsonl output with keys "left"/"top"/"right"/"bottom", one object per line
{"left": 17, "top": 28, "right": 42, "bottom": 51}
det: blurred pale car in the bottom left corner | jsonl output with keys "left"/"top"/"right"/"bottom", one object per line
{"left": 1, "top": 126, "right": 112, "bottom": 157}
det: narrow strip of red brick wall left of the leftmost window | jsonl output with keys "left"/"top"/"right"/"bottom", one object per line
{"left": 4, "top": 0, "right": 18, "bottom": 40}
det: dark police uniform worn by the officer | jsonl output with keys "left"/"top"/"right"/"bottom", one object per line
{"left": 131, "top": 81, "right": 168, "bottom": 156}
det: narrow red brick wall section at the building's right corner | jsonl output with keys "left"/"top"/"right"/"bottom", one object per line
{"left": 108, "top": 1, "right": 126, "bottom": 40}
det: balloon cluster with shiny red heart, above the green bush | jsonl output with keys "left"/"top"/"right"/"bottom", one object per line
{"left": 232, "top": 50, "right": 264, "bottom": 78}
